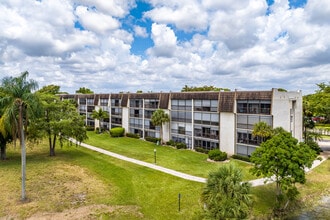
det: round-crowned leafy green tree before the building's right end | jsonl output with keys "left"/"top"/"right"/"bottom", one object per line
{"left": 250, "top": 128, "right": 317, "bottom": 215}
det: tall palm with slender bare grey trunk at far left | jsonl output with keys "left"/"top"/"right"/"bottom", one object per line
{"left": 0, "top": 71, "right": 40, "bottom": 200}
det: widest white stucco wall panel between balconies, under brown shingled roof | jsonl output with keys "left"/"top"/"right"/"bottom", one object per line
{"left": 219, "top": 112, "right": 236, "bottom": 155}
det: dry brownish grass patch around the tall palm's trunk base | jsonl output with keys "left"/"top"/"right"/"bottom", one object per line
{"left": 0, "top": 161, "right": 142, "bottom": 219}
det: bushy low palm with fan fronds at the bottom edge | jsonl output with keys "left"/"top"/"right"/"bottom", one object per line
{"left": 202, "top": 164, "right": 252, "bottom": 219}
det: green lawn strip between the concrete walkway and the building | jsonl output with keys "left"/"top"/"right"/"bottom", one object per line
{"left": 84, "top": 132, "right": 256, "bottom": 180}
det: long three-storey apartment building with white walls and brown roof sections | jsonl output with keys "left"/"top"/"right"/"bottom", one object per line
{"left": 61, "top": 89, "right": 303, "bottom": 155}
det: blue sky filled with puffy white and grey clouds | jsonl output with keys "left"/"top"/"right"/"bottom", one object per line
{"left": 0, "top": 0, "right": 330, "bottom": 94}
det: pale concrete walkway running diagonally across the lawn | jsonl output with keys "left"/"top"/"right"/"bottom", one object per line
{"left": 69, "top": 138, "right": 327, "bottom": 186}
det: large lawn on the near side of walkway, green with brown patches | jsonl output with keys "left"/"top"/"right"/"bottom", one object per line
{"left": 0, "top": 142, "right": 204, "bottom": 219}
